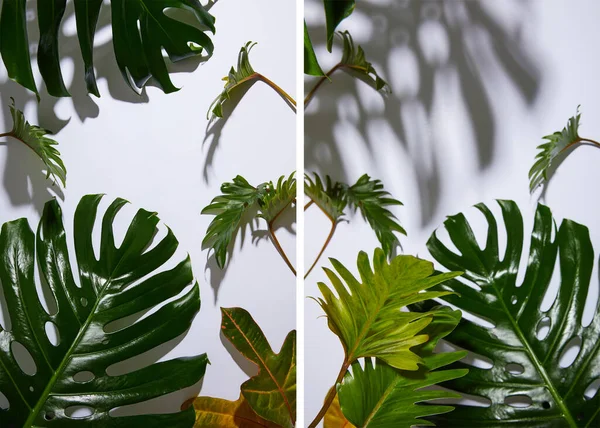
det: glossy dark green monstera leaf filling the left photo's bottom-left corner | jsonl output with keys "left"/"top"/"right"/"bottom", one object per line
{"left": 0, "top": 195, "right": 208, "bottom": 428}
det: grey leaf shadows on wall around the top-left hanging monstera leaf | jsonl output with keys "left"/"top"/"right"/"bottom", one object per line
{"left": 0, "top": 1, "right": 209, "bottom": 213}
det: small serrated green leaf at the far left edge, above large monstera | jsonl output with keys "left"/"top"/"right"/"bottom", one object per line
{"left": 0, "top": 98, "right": 67, "bottom": 187}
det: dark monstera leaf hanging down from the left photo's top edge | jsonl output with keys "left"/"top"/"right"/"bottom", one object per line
{"left": 0, "top": 0, "right": 215, "bottom": 98}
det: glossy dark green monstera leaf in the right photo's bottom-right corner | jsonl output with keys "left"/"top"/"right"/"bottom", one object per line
{"left": 420, "top": 201, "right": 600, "bottom": 427}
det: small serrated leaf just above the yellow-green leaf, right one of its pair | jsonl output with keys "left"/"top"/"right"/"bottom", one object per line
{"left": 345, "top": 174, "right": 406, "bottom": 257}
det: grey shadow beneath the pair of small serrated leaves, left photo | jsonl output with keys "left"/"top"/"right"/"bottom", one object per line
{"left": 202, "top": 204, "right": 296, "bottom": 306}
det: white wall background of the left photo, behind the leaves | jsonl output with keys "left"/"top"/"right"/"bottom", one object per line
{"left": 0, "top": 0, "right": 296, "bottom": 411}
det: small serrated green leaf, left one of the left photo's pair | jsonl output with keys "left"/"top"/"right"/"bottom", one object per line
{"left": 202, "top": 175, "right": 266, "bottom": 269}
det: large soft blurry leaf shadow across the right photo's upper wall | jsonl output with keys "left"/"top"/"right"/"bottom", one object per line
{"left": 305, "top": 0, "right": 541, "bottom": 225}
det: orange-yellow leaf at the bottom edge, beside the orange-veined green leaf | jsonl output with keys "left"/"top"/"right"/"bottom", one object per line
{"left": 182, "top": 395, "right": 280, "bottom": 428}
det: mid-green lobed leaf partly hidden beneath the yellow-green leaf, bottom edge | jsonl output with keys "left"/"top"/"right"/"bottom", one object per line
{"left": 338, "top": 309, "right": 468, "bottom": 428}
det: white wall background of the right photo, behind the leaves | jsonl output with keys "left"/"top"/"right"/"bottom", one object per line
{"left": 305, "top": 0, "right": 600, "bottom": 421}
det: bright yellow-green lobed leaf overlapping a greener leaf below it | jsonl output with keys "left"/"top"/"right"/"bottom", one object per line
{"left": 317, "top": 248, "right": 460, "bottom": 370}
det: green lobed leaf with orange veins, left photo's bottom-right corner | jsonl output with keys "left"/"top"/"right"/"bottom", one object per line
{"left": 221, "top": 308, "right": 296, "bottom": 427}
